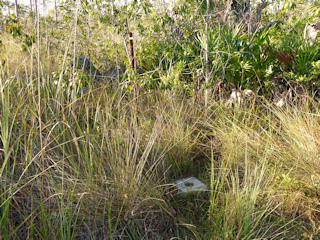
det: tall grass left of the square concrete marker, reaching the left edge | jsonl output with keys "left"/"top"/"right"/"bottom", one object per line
{"left": 1, "top": 35, "right": 202, "bottom": 239}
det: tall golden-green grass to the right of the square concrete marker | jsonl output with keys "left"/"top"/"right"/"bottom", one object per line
{"left": 209, "top": 100, "right": 319, "bottom": 239}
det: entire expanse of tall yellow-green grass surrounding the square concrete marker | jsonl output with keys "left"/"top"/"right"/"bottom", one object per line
{"left": 0, "top": 29, "right": 320, "bottom": 239}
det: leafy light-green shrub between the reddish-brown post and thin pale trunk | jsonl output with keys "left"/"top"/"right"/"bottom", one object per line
{"left": 137, "top": 1, "right": 201, "bottom": 89}
